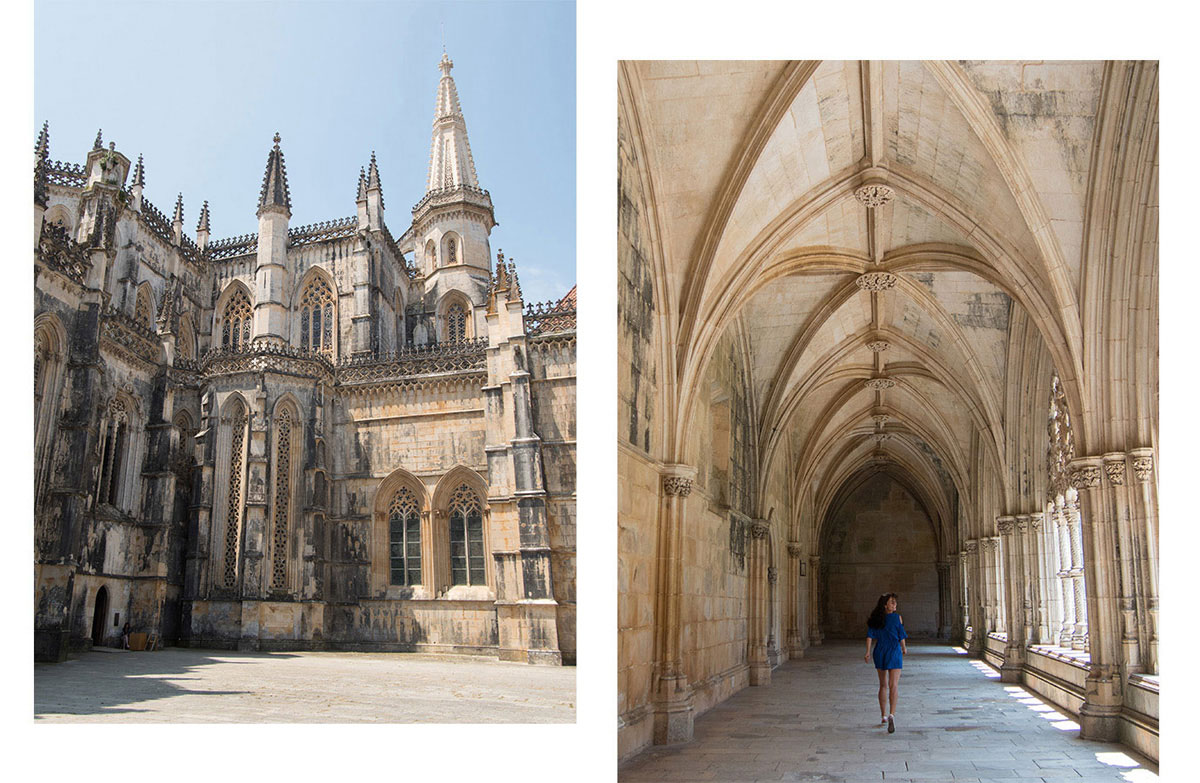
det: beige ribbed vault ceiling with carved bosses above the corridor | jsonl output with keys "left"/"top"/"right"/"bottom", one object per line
{"left": 626, "top": 61, "right": 1104, "bottom": 538}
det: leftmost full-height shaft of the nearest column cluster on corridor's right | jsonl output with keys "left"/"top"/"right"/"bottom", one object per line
{"left": 1070, "top": 458, "right": 1121, "bottom": 741}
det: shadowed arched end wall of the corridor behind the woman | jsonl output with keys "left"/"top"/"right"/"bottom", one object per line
{"left": 821, "top": 473, "right": 938, "bottom": 639}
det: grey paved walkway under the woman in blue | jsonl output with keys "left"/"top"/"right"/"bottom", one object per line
{"left": 619, "top": 644, "right": 1158, "bottom": 783}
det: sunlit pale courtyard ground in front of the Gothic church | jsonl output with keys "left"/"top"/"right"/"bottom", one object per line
{"left": 34, "top": 647, "right": 575, "bottom": 723}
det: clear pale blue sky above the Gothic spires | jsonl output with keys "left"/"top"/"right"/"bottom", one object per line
{"left": 30, "top": 0, "right": 575, "bottom": 301}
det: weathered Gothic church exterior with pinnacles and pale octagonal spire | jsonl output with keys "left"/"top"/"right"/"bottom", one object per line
{"left": 34, "top": 56, "right": 576, "bottom": 664}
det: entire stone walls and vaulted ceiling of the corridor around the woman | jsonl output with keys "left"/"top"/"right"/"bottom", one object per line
{"left": 616, "top": 60, "right": 1158, "bottom": 758}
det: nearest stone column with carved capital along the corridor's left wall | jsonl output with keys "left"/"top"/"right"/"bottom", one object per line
{"left": 653, "top": 465, "right": 696, "bottom": 745}
